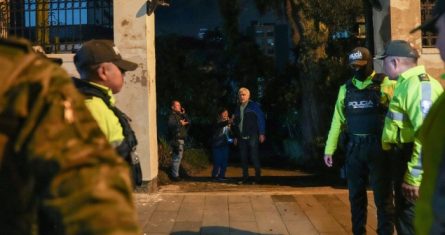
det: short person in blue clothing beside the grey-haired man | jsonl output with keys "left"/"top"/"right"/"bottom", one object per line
{"left": 212, "top": 108, "right": 233, "bottom": 181}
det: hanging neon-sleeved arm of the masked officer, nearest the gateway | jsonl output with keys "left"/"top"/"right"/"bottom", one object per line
{"left": 324, "top": 85, "right": 346, "bottom": 167}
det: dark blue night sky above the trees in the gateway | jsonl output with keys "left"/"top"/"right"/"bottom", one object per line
{"left": 155, "top": 0, "right": 284, "bottom": 37}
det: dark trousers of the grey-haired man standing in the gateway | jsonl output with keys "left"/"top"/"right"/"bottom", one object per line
{"left": 238, "top": 136, "right": 261, "bottom": 179}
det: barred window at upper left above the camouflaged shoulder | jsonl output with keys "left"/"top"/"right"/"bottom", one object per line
{"left": 0, "top": 0, "right": 113, "bottom": 53}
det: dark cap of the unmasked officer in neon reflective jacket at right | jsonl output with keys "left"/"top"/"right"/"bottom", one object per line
{"left": 375, "top": 40, "right": 419, "bottom": 60}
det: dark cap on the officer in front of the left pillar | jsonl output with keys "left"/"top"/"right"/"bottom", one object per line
{"left": 74, "top": 40, "right": 138, "bottom": 71}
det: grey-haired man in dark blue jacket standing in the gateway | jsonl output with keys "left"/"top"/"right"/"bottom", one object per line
{"left": 233, "top": 87, "right": 266, "bottom": 183}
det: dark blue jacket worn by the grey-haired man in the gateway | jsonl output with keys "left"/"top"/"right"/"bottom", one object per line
{"left": 233, "top": 100, "right": 266, "bottom": 137}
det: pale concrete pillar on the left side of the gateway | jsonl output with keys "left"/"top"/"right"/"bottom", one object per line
{"left": 113, "top": 0, "right": 158, "bottom": 191}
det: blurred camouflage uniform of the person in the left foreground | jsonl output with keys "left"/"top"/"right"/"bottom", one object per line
{"left": 0, "top": 37, "right": 141, "bottom": 235}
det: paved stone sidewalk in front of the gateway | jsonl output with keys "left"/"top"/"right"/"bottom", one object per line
{"left": 135, "top": 187, "right": 376, "bottom": 235}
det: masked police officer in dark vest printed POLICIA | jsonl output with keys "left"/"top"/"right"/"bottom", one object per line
{"left": 324, "top": 47, "right": 394, "bottom": 234}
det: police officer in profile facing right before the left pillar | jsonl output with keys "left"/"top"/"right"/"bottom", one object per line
{"left": 74, "top": 40, "right": 142, "bottom": 185}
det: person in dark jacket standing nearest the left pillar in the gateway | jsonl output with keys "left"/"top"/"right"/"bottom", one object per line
{"left": 168, "top": 100, "right": 190, "bottom": 181}
